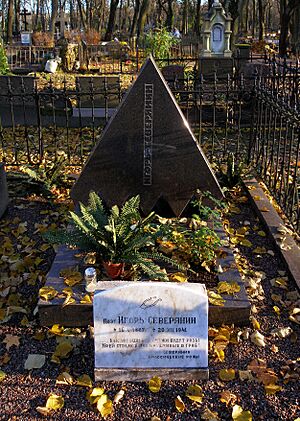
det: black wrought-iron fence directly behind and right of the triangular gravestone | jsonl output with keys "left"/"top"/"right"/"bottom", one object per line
{"left": 0, "top": 57, "right": 300, "bottom": 230}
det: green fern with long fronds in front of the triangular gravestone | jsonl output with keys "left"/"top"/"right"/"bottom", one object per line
{"left": 45, "top": 192, "right": 182, "bottom": 280}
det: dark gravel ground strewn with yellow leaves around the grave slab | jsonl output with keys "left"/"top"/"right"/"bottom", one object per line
{"left": 0, "top": 162, "right": 300, "bottom": 421}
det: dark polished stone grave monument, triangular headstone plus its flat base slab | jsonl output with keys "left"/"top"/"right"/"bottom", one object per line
{"left": 39, "top": 59, "right": 250, "bottom": 326}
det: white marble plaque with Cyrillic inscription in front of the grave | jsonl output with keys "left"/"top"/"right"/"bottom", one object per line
{"left": 94, "top": 282, "right": 208, "bottom": 369}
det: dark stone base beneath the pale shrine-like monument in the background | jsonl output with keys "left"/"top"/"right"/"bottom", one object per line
{"left": 199, "top": 57, "right": 233, "bottom": 78}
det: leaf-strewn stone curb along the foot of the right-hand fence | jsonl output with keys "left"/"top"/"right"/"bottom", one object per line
{"left": 243, "top": 178, "right": 300, "bottom": 290}
